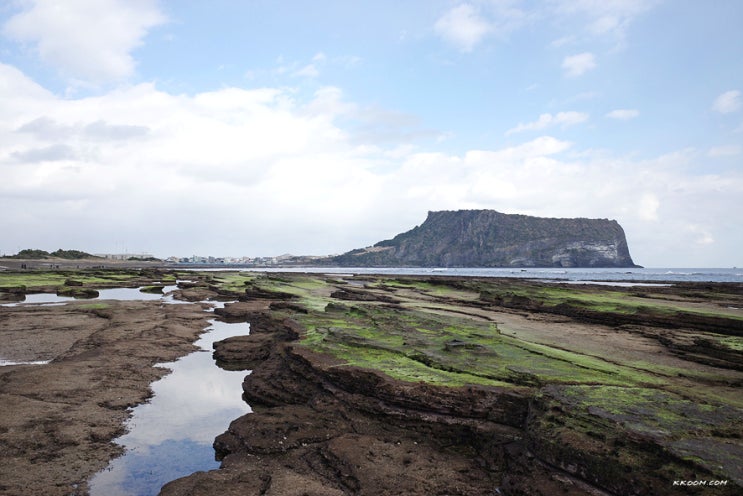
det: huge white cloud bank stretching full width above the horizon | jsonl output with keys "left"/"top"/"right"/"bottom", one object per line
{"left": 0, "top": 64, "right": 743, "bottom": 266}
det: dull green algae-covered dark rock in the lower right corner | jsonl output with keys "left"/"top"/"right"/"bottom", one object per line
{"left": 529, "top": 385, "right": 743, "bottom": 492}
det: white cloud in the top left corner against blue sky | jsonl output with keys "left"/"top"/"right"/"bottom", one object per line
{"left": 2, "top": 0, "right": 166, "bottom": 84}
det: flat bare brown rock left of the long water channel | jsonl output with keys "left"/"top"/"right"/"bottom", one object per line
{"left": 0, "top": 301, "right": 207, "bottom": 496}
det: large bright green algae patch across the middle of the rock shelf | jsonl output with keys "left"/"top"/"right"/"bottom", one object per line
{"left": 297, "top": 305, "right": 659, "bottom": 386}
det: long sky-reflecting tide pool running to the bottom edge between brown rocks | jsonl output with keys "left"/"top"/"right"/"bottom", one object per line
{"left": 90, "top": 320, "right": 250, "bottom": 496}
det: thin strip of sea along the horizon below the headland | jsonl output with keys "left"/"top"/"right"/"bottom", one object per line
{"left": 208, "top": 267, "right": 743, "bottom": 286}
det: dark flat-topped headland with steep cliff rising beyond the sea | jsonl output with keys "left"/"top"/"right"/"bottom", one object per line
{"left": 333, "top": 210, "right": 636, "bottom": 267}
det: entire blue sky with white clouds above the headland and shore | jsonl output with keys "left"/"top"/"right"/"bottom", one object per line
{"left": 0, "top": 0, "right": 743, "bottom": 267}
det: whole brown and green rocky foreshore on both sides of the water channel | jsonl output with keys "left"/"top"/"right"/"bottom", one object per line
{"left": 0, "top": 272, "right": 743, "bottom": 495}
